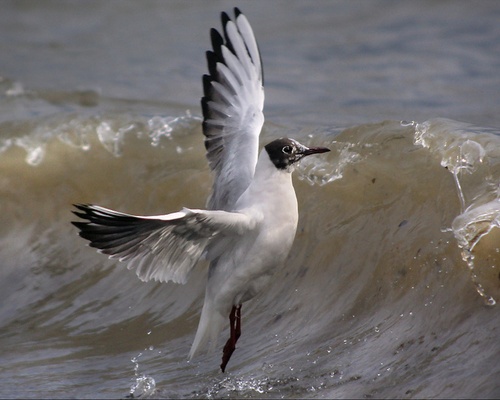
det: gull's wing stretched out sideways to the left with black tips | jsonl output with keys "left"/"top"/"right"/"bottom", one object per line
{"left": 72, "top": 204, "right": 252, "bottom": 283}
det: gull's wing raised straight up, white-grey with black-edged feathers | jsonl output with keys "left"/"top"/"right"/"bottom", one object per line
{"left": 201, "top": 8, "right": 264, "bottom": 211}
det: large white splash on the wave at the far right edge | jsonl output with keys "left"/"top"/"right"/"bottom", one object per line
{"left": 413, "top": 119, "right": 500, "bottom": 306}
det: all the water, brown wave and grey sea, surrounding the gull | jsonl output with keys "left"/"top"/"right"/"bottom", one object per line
{"left": 0, "top": 1, "right": 500, "bottom": 398}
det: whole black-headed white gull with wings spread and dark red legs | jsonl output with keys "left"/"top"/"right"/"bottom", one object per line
{"left": 73, "top": 8, "right": 329, "bottom": 372}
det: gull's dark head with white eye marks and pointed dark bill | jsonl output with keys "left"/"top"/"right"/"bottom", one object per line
{"left": 264, "top": 138, "right": 330, "bottom": 172}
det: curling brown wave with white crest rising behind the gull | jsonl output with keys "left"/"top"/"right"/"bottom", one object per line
{"left": 0, "top": 113, "right": 500, "bottom": 397}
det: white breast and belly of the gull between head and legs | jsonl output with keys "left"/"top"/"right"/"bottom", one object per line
{"left": 207, "top": 172, "right": 298, "bottom": 314}
